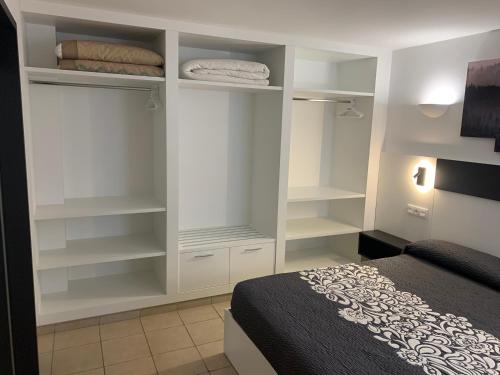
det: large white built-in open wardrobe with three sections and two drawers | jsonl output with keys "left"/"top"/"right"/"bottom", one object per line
{"left": 19, "top": 4, "right": 384, "bottom": 325}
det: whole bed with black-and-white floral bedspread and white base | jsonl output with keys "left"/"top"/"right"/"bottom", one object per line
{"left": 225, "top": 241, "right": 500, "bottom": 375}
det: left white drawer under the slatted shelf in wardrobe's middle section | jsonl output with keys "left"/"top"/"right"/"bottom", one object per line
{"left": 179, "top": 248, "right": 229, "bottom": 292}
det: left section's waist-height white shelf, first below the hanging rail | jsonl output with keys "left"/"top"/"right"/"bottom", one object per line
{"left": 34, "top": 196, "right": 166, "bottom": 220}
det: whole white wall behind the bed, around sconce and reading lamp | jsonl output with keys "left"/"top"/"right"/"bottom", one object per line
{"left": 375, "top": 31, "right": 500, "bottom": 256}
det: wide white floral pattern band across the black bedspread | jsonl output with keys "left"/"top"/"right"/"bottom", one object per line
{"left": 300, "top": 264, "right": 500, "bottom": 375}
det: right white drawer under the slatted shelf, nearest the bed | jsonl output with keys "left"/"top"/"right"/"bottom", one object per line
{"left": 229, "top": 242, "right": 274, "bottom": 284}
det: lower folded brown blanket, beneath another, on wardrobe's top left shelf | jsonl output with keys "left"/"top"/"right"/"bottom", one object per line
{"left": 59, "top": 60, "right": 165, "bottom": 77}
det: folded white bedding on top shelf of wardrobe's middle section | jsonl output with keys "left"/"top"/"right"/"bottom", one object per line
{"left": 181, "top": 59, "right": 269, "bottom": 86}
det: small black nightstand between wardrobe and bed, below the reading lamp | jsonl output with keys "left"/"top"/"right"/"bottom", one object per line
{"left": 358, "top": 230, "right": 410, "bottom": 260}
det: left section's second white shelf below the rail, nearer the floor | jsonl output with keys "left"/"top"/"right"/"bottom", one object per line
{"left": 38, "top": 234, "right": 166, "bottom": 270}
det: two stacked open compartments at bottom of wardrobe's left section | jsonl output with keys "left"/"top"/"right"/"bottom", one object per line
{"left": 36, "top": 212, "right": 167, "bottom": 322}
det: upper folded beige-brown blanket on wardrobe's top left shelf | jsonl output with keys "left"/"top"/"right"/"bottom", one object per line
{"left": 55, "top": 40, "right": 164, "bottom": 66}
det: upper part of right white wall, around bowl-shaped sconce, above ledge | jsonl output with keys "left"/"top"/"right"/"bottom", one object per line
{"left": 384, "top": 30, "right": 500, "bottom": 164}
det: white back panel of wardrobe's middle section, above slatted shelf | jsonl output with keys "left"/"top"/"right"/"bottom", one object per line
{"left": 179, "top": 90, "right": 229, "bottom": 230}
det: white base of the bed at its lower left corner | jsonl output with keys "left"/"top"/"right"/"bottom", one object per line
{"left": 224, "top": 309, "right": 278, "bottom": 375}
